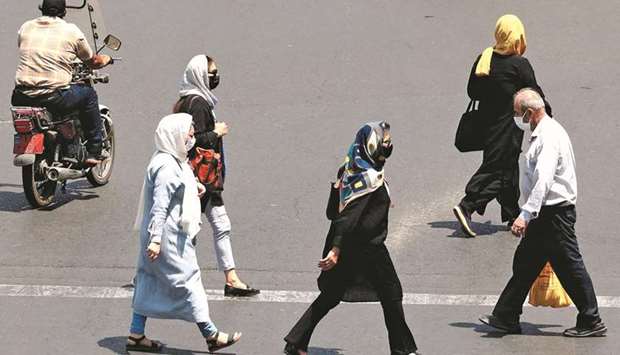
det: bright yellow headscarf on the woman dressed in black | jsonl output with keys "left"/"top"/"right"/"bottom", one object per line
{"left": 476, "top": 15, "right": 527, "bottom": 76}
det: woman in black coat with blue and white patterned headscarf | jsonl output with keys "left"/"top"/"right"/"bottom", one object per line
{"left": 284, "top": 121, "right": 417, "bottom": 355}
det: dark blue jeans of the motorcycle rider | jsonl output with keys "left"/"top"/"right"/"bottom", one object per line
{"left": 11, "top": 85, "right": 103, "bottom": 154}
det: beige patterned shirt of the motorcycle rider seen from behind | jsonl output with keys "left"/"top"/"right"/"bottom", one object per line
{"left": 15, "top": 16, "right": 93, "bottom": 96}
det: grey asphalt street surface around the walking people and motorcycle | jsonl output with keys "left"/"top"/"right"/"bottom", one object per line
{"left": 0, "top": 0, "right": 620, "bottom": 355}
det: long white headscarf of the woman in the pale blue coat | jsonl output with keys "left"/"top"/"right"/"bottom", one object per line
{"left": 134, "top": 113, "right": 202, "bottom": 238}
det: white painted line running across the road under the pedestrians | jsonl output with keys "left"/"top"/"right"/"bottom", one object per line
{"left": 0, "top": 284, "right": 620, "bottom": 308}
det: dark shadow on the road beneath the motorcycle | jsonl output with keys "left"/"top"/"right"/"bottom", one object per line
{"left": 0, "top": 180, "right": 99, "bottom": 213}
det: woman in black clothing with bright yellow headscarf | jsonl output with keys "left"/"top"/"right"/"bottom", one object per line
{"left": 453, "top": 15, "right": 551, "bottom": 237}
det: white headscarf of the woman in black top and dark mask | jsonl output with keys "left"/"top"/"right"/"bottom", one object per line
{"left": 179, "top": 54, "right": 218, "bottom": 108}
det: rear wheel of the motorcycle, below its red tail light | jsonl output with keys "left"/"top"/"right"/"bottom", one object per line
{"left": 22, "top": 156, "right": 58, "bottom": 208}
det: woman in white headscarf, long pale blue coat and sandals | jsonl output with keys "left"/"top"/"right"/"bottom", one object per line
{"left": 126, "top": 114, "right": 241, "bottom": 352}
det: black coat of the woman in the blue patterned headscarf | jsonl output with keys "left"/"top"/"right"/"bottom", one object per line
{"left": 318, "top": 185, "right": 402, "bottom": 302}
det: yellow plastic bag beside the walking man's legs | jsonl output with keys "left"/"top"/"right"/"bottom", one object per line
{"left": 529, "top": 263, "right": 572, "bottom": 308}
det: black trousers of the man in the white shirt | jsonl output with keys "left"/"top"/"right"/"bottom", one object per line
{"left": 493, "top": 206, "right": 601, "bottom": 327}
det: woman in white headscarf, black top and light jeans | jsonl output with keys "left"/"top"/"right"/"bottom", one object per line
{"left": 174, "top": 54, "right": 260, "bottom": 297}
